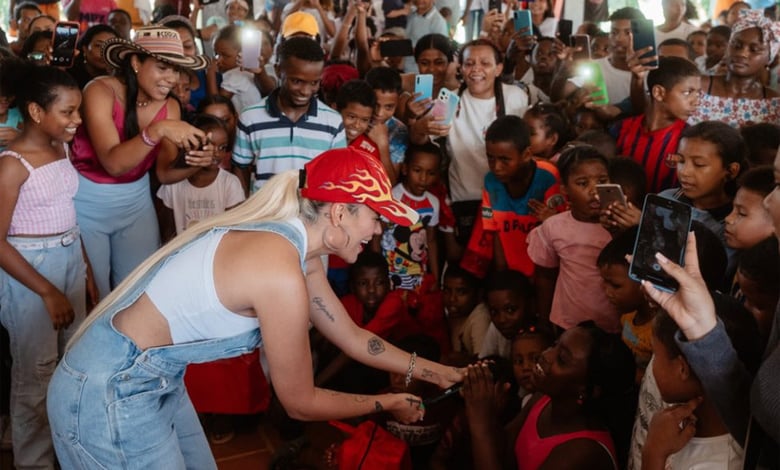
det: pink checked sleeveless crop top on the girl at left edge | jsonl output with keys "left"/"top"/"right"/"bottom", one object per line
{"left": 0, "top": 150, "right": 79, "bottom": 235}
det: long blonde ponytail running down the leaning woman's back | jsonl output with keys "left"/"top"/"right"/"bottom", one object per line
{"left": 68, "top": 170, "right": 316, "bottom": 348}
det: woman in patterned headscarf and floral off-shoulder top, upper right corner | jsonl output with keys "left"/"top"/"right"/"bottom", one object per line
{"left": 688, "top": 10, "right": 780, "bottom": 127}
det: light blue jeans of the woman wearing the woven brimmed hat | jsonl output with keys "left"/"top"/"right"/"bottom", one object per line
{"left": 74, "top": 174, "right": 160, "bottom": 298}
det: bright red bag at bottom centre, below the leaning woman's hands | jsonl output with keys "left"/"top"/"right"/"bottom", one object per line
{"left": 329, "top": 420, "right": 412, "bottom": 470}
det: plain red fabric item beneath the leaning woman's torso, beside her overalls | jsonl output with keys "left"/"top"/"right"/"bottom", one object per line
{"left": 184, "top": 349, "right": 271, "bottom": 414}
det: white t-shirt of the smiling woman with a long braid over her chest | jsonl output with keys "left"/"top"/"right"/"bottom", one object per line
{"left": 447, "top": 84, "right": 528, "bottom": 202}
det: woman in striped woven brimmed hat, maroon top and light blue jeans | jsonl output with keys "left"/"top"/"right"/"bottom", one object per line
{"left": 72, "top": 26, "right": 214, "bottom": 296}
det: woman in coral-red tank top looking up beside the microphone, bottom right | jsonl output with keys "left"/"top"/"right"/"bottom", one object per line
{"left": 464, "top": 321, "right": 635, "bottom": 470}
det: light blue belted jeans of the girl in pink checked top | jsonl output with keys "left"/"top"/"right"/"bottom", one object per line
{"left": 0, "top": 229, "right": 86, "bottom": 469}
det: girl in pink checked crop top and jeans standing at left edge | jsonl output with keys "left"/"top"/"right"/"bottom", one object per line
{"left": 0, "top": 64, "right": 94, "bottom": 468}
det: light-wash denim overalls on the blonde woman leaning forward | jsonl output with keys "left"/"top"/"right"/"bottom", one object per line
{"left": 47, "top": 218, "right": 305, "bottom": 470}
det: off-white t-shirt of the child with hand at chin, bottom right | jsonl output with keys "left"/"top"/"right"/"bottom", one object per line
{"left": 666, "top": 434, "right": 744, "bottom": 470}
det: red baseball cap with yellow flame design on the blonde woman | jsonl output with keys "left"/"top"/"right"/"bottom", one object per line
{"left": 300, "top": 147, "right": 420, "bottom": 226}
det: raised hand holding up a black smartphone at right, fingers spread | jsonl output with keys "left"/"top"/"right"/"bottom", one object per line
{"left": 642, "top": 232, "right": 717, "bottom": 341}
